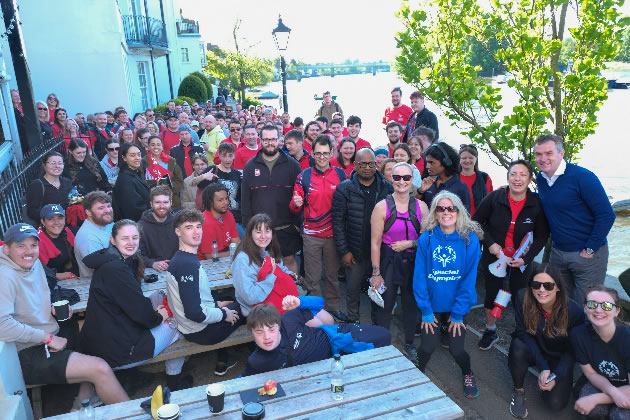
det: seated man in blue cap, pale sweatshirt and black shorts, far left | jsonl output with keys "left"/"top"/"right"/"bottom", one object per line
{"left": 0, "top": 223, "right": 129, "bottom": 408}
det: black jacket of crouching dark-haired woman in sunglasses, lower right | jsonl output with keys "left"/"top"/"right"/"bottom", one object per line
{"left": 512, "top": 289, "right": 586, "bottom": 378}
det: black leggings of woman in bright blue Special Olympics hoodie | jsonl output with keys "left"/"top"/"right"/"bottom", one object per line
{"left": 418, "top": 312, "right": 471, "bottom": 375}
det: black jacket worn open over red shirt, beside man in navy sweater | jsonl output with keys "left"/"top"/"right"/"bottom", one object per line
{"left": 473, "top": 188, "right": 549, "bottom": 264}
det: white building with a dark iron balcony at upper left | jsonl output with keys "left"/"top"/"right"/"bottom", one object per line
{"left": 7, "top": 0, "right": 205, "bottom": 116}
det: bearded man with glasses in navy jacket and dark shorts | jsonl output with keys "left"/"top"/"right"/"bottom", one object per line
{"left": 241, "top": 125, "right": 301, "bottom": 273}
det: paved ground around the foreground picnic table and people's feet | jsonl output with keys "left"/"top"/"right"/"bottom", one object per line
{"left": 43, "top": 276, "right": 580, "bottom": 420}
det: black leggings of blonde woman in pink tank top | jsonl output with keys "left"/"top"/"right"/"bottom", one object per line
{"left": 376, "top": 264, "right": 418, "bottom": 344}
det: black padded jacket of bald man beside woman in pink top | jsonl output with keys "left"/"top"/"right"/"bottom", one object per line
{"left": 332, "top": 171, "right": 394, "bottom": 261}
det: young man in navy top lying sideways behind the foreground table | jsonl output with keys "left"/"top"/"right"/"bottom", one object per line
{"left": 243, "top": 296, "right": 392, "bottom": 376}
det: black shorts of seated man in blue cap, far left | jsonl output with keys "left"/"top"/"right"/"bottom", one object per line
{"left": 18, "top": 315, "right": 79, "bottom": 385}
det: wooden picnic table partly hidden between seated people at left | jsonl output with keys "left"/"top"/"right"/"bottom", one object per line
{"left": 59, "top": 257, "right": 232, "bottom": 312}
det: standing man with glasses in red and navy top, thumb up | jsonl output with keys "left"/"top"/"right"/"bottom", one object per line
{"left": 292, "top": 136, "right": 348, "bottom": 322}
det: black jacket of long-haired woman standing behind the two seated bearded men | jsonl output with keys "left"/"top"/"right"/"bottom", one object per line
{"left": 112, "top": 167, "right": 151, "bottom": 222}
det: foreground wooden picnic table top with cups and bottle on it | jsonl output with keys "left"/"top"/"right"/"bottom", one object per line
{"left": 40, "top": 346, "right": 464, "bottom": 420}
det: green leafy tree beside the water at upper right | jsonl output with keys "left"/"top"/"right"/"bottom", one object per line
{"left": 396, "top": 0, "right": 630, "bottom": 167}
